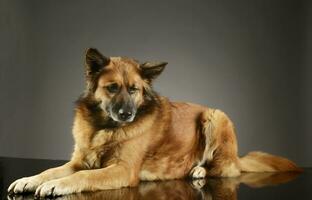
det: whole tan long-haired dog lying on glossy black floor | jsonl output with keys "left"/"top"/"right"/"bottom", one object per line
{"left": 8, "top": 49, "right": 300, "bottom": 196}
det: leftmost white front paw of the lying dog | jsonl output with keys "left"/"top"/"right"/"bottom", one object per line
{"left": 8, "top": 176, "right": 42, "bottom": 194}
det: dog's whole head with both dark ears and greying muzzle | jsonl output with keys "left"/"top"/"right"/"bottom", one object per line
{"left": 85, "top": 48, "right": 167, "bottom": 124}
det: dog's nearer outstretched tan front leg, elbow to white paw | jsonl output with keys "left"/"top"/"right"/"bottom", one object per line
{"left": 35, "top": 164, "right": 139, "bottom": 197}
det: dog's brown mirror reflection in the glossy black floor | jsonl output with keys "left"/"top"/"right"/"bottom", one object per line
{"left": 8, "top": 173, "right": 298, "bottom": 200}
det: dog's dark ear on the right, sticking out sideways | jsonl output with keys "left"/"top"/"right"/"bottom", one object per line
{"left": 140, "top": 62, "right": 168, "bottom": 81}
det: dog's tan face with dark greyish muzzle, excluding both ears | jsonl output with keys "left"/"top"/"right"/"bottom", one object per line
{"left": 95, "top": 58, "right": 146, "bottom": 123}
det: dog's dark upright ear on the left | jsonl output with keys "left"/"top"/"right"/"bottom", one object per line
{"left": 86, "top": 48, "right": 110, "bottom": 76}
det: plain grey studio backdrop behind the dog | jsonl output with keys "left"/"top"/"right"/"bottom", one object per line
{"left": 0, "top": 0, "right": 312, "bottom": 166}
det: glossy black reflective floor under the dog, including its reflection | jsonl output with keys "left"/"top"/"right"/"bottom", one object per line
{"left": 0, "top": 158, "right": 312, "bottom": 200}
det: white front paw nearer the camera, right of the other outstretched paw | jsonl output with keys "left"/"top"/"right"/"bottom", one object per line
{"left": 35, "top": 179, "right": 77, "bottom": 197}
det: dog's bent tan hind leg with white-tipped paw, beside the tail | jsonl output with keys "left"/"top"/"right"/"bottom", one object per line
{"left": 190, "top": 109, "right": 241, "bottom": 178}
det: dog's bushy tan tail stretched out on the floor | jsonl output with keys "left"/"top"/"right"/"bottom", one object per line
{"left": 239, "top": 151, "right": 303, "bottom": 172}
